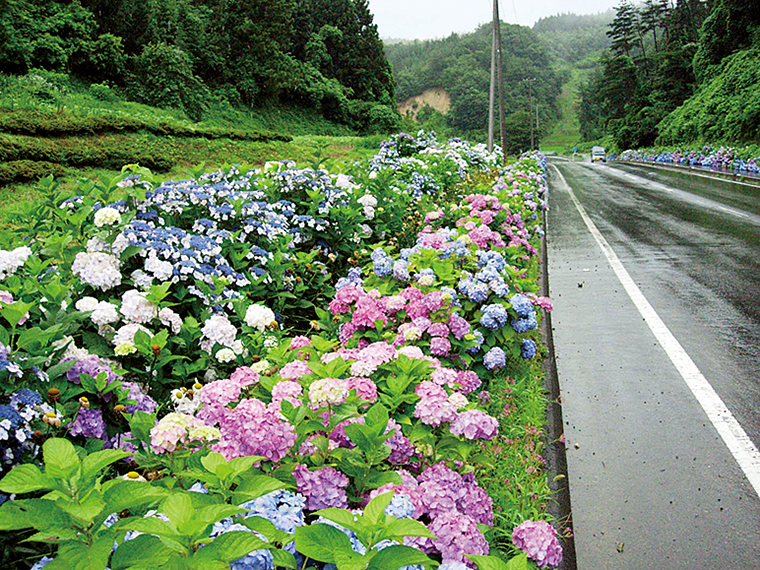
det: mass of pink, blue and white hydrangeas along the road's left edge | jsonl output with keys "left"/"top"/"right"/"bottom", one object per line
{"left": 0, "top": 133, "right": 559, "bottom": 570}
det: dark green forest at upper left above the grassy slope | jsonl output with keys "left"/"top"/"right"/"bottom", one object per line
{"left": 0, "top": 0, "right": 398, "bottom": 131}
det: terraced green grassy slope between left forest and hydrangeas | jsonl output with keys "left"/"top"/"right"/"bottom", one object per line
{"left": 0, "top": 71, "right": 384, "bottom": 225}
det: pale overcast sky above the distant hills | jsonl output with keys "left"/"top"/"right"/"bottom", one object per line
{"left": 369, "top": 0, "right": 619, "bottom": 39}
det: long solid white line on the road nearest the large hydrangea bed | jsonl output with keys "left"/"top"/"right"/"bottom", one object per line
{"left": 552, "top": 164, "right": 760, "bottom": 495}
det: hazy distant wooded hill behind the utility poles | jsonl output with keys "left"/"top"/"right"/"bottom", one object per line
{"left": 385, "top": 22, "right": 562, "bottom": 153}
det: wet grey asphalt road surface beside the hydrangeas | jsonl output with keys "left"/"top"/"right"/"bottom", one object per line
{"left": 547, "top": 161, "right": 760, "bottom": 570}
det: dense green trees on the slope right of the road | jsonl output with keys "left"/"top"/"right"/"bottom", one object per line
{"left": 579, "top": 0, "right": 760, "bottom": 150}
